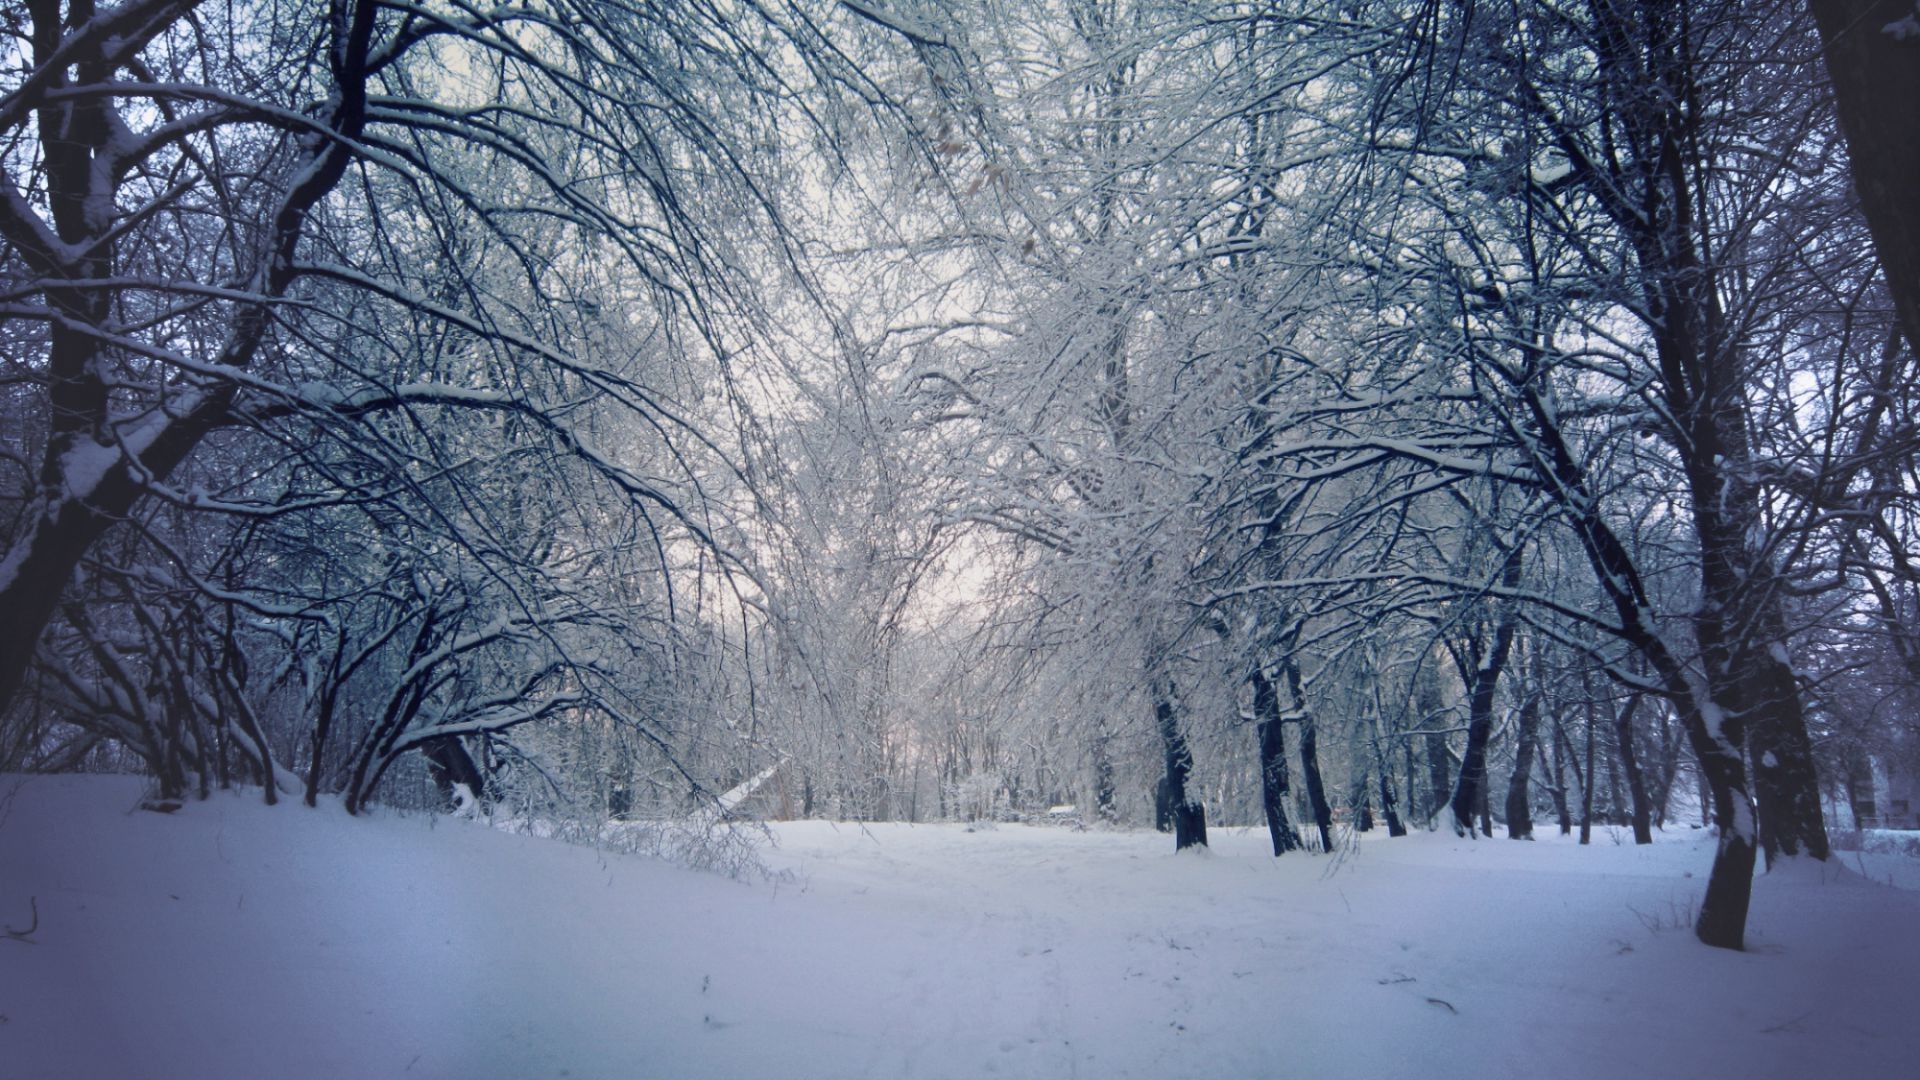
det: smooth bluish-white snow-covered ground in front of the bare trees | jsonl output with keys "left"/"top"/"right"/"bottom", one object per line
{"left": 0, "top": 778, "right": 1920, "bottom": 1080}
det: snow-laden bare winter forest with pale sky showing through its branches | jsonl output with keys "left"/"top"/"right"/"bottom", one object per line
{"left": 0, "top": 0, "right": 1920, "bottom": 1076}
